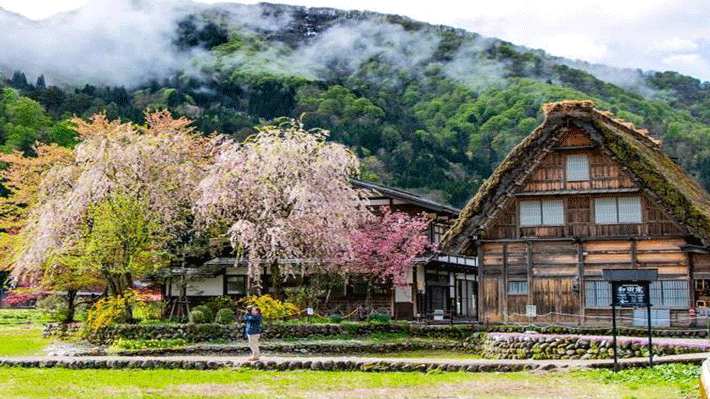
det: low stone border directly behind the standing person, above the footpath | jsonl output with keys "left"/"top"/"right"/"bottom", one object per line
{"left": 111, "top": 342, "right": 468, "bottom": 356}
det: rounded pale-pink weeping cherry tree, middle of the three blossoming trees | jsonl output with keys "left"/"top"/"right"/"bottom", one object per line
{"left": 197, "top": 121, "right": 367, "bottom": 296}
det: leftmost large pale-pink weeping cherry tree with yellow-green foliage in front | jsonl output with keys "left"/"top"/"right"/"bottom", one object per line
{"left": 13, "top": 111, "right": 212, "bottom": 302}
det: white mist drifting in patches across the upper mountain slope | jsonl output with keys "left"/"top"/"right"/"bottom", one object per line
{"left": 0, "top": 0, "right": 668, "bottom": 92}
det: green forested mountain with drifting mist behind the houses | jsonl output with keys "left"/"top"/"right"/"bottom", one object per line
{"left": 0, "top": 0, "right": 710, "bottom": 206}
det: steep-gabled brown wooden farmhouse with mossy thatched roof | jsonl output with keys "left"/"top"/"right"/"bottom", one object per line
{"left": 442, "top": 102, "right": 710, "bottom": 326}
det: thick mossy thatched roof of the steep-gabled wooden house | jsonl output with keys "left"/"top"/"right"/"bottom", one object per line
{"left": 441, "top": 101, "right": 710, "bottom": 254}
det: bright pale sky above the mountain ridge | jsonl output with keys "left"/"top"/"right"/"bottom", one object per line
{"left": 0, "top": 0, "right": 710, "bottom": 80}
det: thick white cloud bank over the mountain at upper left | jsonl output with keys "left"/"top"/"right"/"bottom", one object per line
{"left": 0, "top": 0, "right": 200, "bottom": 85}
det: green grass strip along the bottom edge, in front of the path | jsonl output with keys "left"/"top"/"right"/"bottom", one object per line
{"left": 0, "top": 366, "right": 697, "bottom": 399}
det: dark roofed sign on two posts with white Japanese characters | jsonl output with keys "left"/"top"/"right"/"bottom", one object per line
{"left": 602, "top": 269, "right": 658, "bottom": 371}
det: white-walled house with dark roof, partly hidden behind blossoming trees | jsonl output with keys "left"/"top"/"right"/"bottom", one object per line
{"left": 163, "top": 179, "right": 476, "bottom": 320}
